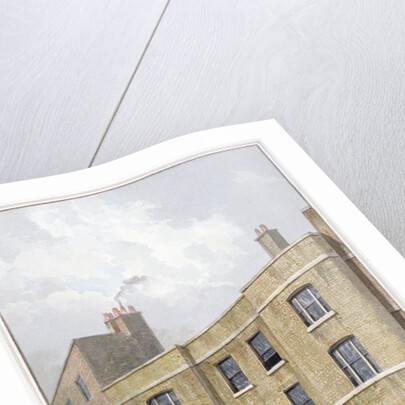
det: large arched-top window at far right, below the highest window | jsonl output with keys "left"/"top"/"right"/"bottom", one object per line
{"left": 330, "top": 336, "right": 381, "bottom": 387}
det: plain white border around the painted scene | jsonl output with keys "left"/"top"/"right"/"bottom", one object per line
{"left": 0, "top": 120, "right": 405, "bottom": 404}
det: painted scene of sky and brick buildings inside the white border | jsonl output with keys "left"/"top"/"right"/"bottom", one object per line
{"left": 0, "top": 147, "right": 405, "bottom": 405}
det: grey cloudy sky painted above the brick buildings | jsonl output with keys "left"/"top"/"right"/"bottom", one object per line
{"left": 0, "top": 147, "right": 313, "bottom": 397}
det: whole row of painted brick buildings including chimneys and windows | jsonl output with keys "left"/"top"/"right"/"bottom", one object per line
{"left": 52, "top": 208, "right": 405, "bottom": 405}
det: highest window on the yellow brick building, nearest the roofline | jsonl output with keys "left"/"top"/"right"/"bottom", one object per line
{"left": 290, "top": 285, "right": 331, "bottom": 326}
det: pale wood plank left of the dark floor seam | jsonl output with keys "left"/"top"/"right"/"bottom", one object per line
{"left": 0, "top": 0, "right": 166, "bottom": 182}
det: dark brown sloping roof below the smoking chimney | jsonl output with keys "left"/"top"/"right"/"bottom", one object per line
{"left": 73, "top": 333, "right": 155, "bottom": 387}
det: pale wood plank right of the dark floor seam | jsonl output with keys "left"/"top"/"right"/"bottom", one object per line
{"left": 92, "top": 0, "right": 405, "bottom": 254}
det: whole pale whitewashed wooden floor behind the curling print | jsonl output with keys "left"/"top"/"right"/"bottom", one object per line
{"left": 0, "top": 0, "right": 405, "bottom": 254}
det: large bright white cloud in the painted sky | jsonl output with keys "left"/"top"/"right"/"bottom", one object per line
{"left": 0, "top": 197, "right": 246, "bottom": 306}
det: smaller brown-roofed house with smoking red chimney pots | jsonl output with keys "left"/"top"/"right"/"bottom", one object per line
{"left": 52, "top": 305, "right": 164, "bottom": 405}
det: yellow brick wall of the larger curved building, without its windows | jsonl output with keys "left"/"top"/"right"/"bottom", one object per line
{"left": 105, "top": 235, "right": 405, "bottom": 405}
